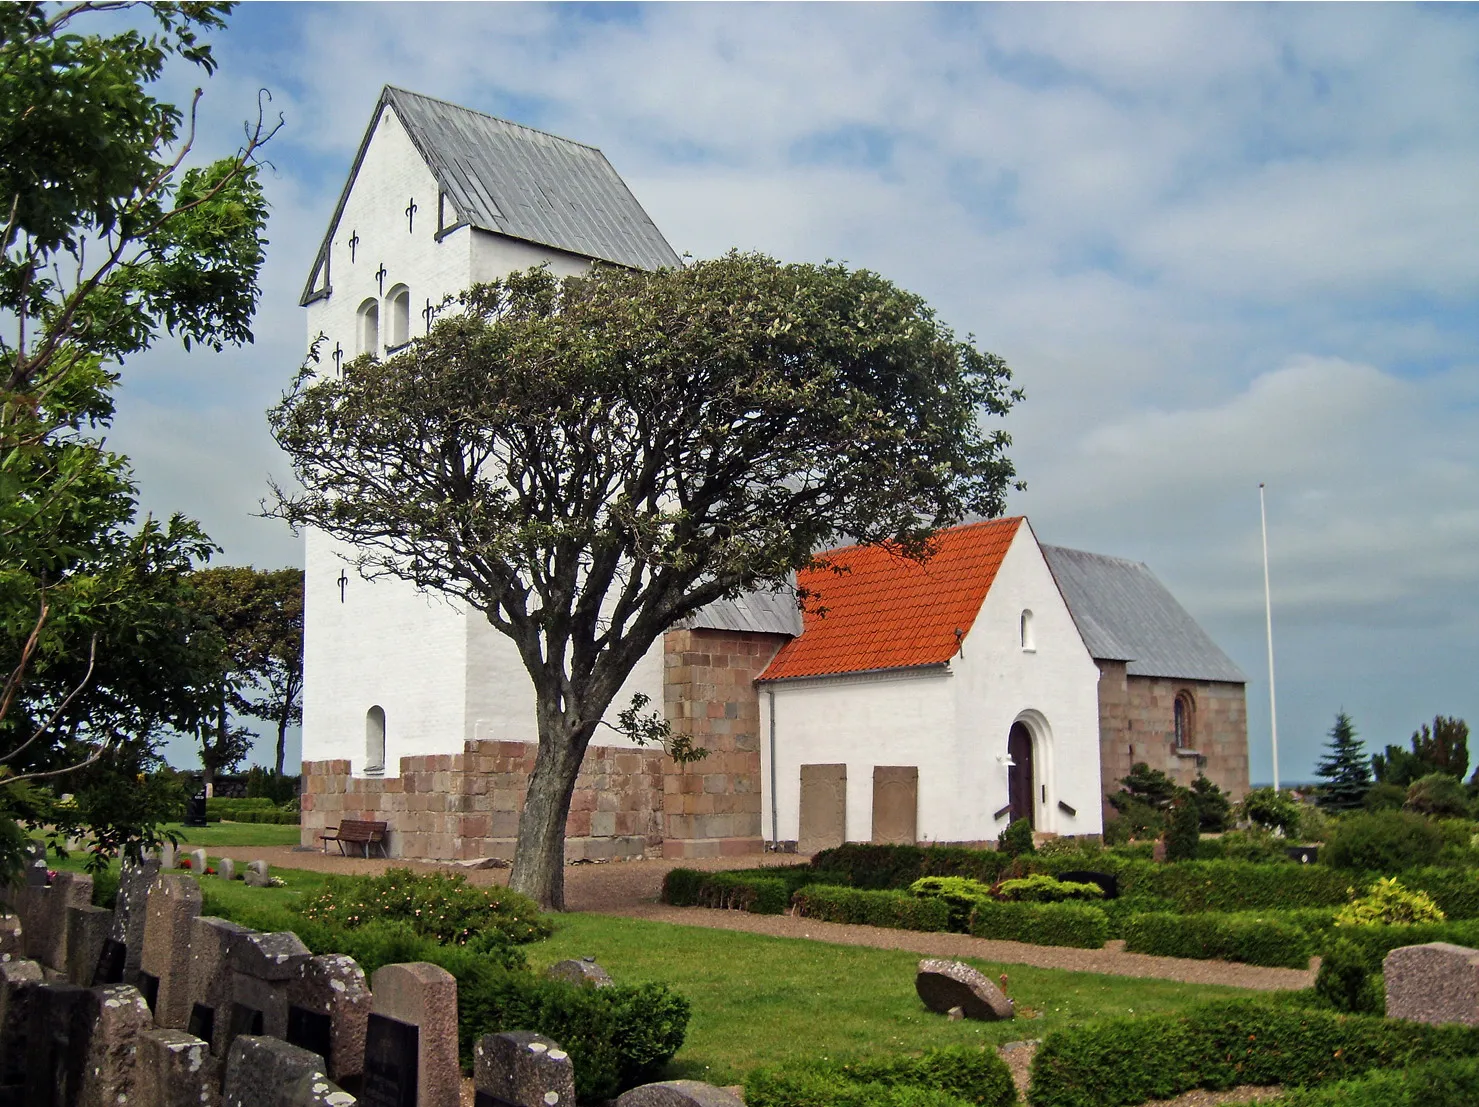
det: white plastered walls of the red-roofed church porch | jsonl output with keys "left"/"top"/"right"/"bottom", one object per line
{"left": 759, "top": 522, "right": 1102, "bottom": 842}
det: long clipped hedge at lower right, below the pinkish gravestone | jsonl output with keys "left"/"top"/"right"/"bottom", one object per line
{"left": 1028, "top": 999, "right": 1479, "bottom": 1107}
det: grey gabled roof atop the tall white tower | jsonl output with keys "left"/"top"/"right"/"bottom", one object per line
{"left": 303, "top": 84, "right": 682, "bottom": 303}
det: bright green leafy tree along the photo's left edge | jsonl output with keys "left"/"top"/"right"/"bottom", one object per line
{"left": 0, "top": 3, "right": 271, "bottom": 866}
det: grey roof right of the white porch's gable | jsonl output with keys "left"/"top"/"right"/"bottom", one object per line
{"left": 1043, "top": 546, "right": 1248, "bottom": 684}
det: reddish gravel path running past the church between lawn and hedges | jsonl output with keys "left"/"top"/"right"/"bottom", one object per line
{"left": 202, "top": 847, "right": 1315, "bottom": 990}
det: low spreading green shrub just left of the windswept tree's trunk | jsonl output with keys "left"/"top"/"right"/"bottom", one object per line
{"left": 299, "top": 869, "right": 552, "bottom": 944}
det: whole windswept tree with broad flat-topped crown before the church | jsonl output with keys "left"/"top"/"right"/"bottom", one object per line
{"left": 271, "top": 253, "right": 1019, "bottom": 907}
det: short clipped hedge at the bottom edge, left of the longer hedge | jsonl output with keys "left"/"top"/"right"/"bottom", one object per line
{"left": 744, "top": 1046, "right": 1016, "bottom": 1107}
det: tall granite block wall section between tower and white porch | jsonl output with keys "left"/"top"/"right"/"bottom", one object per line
{"left": 663, "top": 630, "right": 787, "bottom": 857}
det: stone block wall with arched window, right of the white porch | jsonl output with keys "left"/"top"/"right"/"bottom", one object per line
{"left": 1099, "top": 662, "right": 1248, "bottom": 817}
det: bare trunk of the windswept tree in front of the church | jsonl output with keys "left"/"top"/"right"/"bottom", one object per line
{"left": 509, "top": 706, "right": 595, "bottom": 912}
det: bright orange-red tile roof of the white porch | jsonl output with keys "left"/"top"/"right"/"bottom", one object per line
{"left": 760, "top": 517, "right": 1022, "bottom": 681}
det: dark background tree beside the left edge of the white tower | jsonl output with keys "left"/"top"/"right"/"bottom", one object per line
{"left": 192, "top": 565, "right": 303, "bottom": 780}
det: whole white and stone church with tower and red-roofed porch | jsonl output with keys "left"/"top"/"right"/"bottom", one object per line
{"left": 302, "top": 87, "right": 1248, "bottom": 860}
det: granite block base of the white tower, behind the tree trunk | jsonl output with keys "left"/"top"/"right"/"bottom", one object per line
{"left": 302, "top": 740, "right": 669, "bottom": 860}
